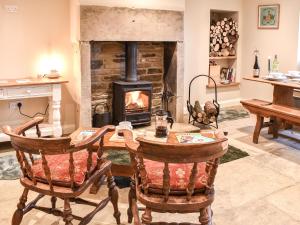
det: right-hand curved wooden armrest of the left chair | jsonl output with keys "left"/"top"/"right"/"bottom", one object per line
{"left": 74, "top": 125, "right": 115, "bottom": 150}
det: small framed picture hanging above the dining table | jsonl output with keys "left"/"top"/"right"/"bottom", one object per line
{"left": 258, "top": 4, "right": 280, "bottom": 29}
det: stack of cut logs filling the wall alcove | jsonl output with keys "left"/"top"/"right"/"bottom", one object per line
{"left": 210, "top": 18, "right": 239, "bottom": 57}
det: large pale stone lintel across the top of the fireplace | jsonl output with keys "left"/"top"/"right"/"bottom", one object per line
{"left": 80, "top": 6, "right": 183, "bottom": 41}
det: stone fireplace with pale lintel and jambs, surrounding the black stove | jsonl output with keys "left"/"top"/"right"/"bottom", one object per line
{"left": 80, "top": 6, "right": 184, "bottom": 126}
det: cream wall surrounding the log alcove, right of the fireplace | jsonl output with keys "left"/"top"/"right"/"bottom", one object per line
{"left": 184, "top": 0, "right": 243, "bottom": 109}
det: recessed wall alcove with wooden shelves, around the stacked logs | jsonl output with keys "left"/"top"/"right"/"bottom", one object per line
{"left": 206, "top": 10, "right": 240, "bottom": 88}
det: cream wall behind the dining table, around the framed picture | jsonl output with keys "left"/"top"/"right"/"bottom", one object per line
{"left": 241, "top": 0, "right": 300, "bottom": 100}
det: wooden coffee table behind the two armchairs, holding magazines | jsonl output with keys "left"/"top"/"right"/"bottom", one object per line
{"left": 70, "top": 123, "right": 200, "bottom": 177}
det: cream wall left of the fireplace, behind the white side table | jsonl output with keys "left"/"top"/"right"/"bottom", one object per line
{"left": 0, "top": 0, "right": 75, "bottom": 132}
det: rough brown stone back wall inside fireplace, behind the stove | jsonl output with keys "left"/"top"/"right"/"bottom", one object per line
{"left": 91, "top": 42, "right": 164, "bottom": 112}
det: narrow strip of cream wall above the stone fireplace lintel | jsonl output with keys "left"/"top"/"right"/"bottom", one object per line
{"left": 80, "top": 0, "right": 185, "bottom": 11}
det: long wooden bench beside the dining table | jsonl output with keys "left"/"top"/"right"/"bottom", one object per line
{"left": 241, "top": 99, "right": 300, "bottom": 144}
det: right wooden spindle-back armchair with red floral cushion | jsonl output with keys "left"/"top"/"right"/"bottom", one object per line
{"left": 124, "top": 131, "right": 228, "bottom": 225}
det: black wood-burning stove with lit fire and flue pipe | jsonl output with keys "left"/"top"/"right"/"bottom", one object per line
{"left": 113, "top": 42, "right": 152, "bottom": 125}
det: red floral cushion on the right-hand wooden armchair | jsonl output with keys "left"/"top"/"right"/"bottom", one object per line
{"left": 144, "top": 160, "right": 208, "bottom": 190}
